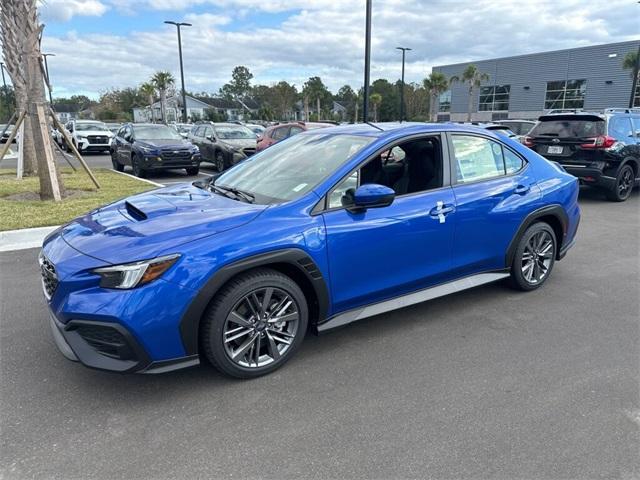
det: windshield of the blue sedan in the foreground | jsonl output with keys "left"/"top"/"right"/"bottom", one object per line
{"left": 215, "top": 133, "right": 374, "bottom": 203}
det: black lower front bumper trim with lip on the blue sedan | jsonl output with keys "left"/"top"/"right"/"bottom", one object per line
{"left": 49, "top": 314, "right": 200, "bottom": 373}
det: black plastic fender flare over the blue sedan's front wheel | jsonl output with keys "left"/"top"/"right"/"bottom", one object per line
{"left": 180, "top": 248, "right": 329, "bottom": 355}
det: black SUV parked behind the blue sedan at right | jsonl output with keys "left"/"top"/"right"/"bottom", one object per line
{"left": 524, "top": 108, "right": 640, "bottom": 202}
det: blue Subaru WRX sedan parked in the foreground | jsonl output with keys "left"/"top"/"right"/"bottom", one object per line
{"left": 40, "top": 123, "right": 580, "bottom": 378}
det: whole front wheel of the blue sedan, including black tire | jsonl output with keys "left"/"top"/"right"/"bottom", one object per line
{"left": 200, "top": 268, "right": 309, "bottom": 378}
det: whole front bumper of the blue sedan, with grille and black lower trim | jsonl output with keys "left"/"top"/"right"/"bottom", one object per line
{"left": 40, "top": 231, "right": 199, "bottom": 373}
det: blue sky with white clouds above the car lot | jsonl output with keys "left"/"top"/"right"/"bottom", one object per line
{"left": 27, "top": 0, "right": 640, "bottom": 98}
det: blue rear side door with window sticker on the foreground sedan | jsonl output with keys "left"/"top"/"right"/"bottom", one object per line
{"left": 448, "top": 133, "right": 542, "bottom": 277}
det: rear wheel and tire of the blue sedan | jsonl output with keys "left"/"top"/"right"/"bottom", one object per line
{"left": 510, "top": 222, "right": 558, "bottom": 292}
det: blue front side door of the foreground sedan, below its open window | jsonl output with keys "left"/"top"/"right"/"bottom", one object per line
{"left": 322, "top": 135, "right": 456, "bottom": 314}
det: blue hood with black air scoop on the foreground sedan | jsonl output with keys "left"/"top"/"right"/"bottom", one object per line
{"left": 61, "top": 183, "right": 267, "bottom": 264}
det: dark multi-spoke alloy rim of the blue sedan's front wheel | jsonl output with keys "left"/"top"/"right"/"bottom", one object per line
{"left": 223, "top": 287, "right": 300, "bottom": 368}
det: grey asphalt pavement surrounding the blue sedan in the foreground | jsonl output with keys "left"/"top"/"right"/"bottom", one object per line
{"left": 0, "top": 186, "right": 640, "bottom": 479}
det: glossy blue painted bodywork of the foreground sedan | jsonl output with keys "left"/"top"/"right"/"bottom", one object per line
{"left": 43, "top": 124, "right": 580, "bottom": 370}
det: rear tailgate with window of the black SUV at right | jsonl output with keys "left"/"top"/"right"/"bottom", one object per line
{"left": 529, "top": 114, "right": 606, "bottom": 168}
